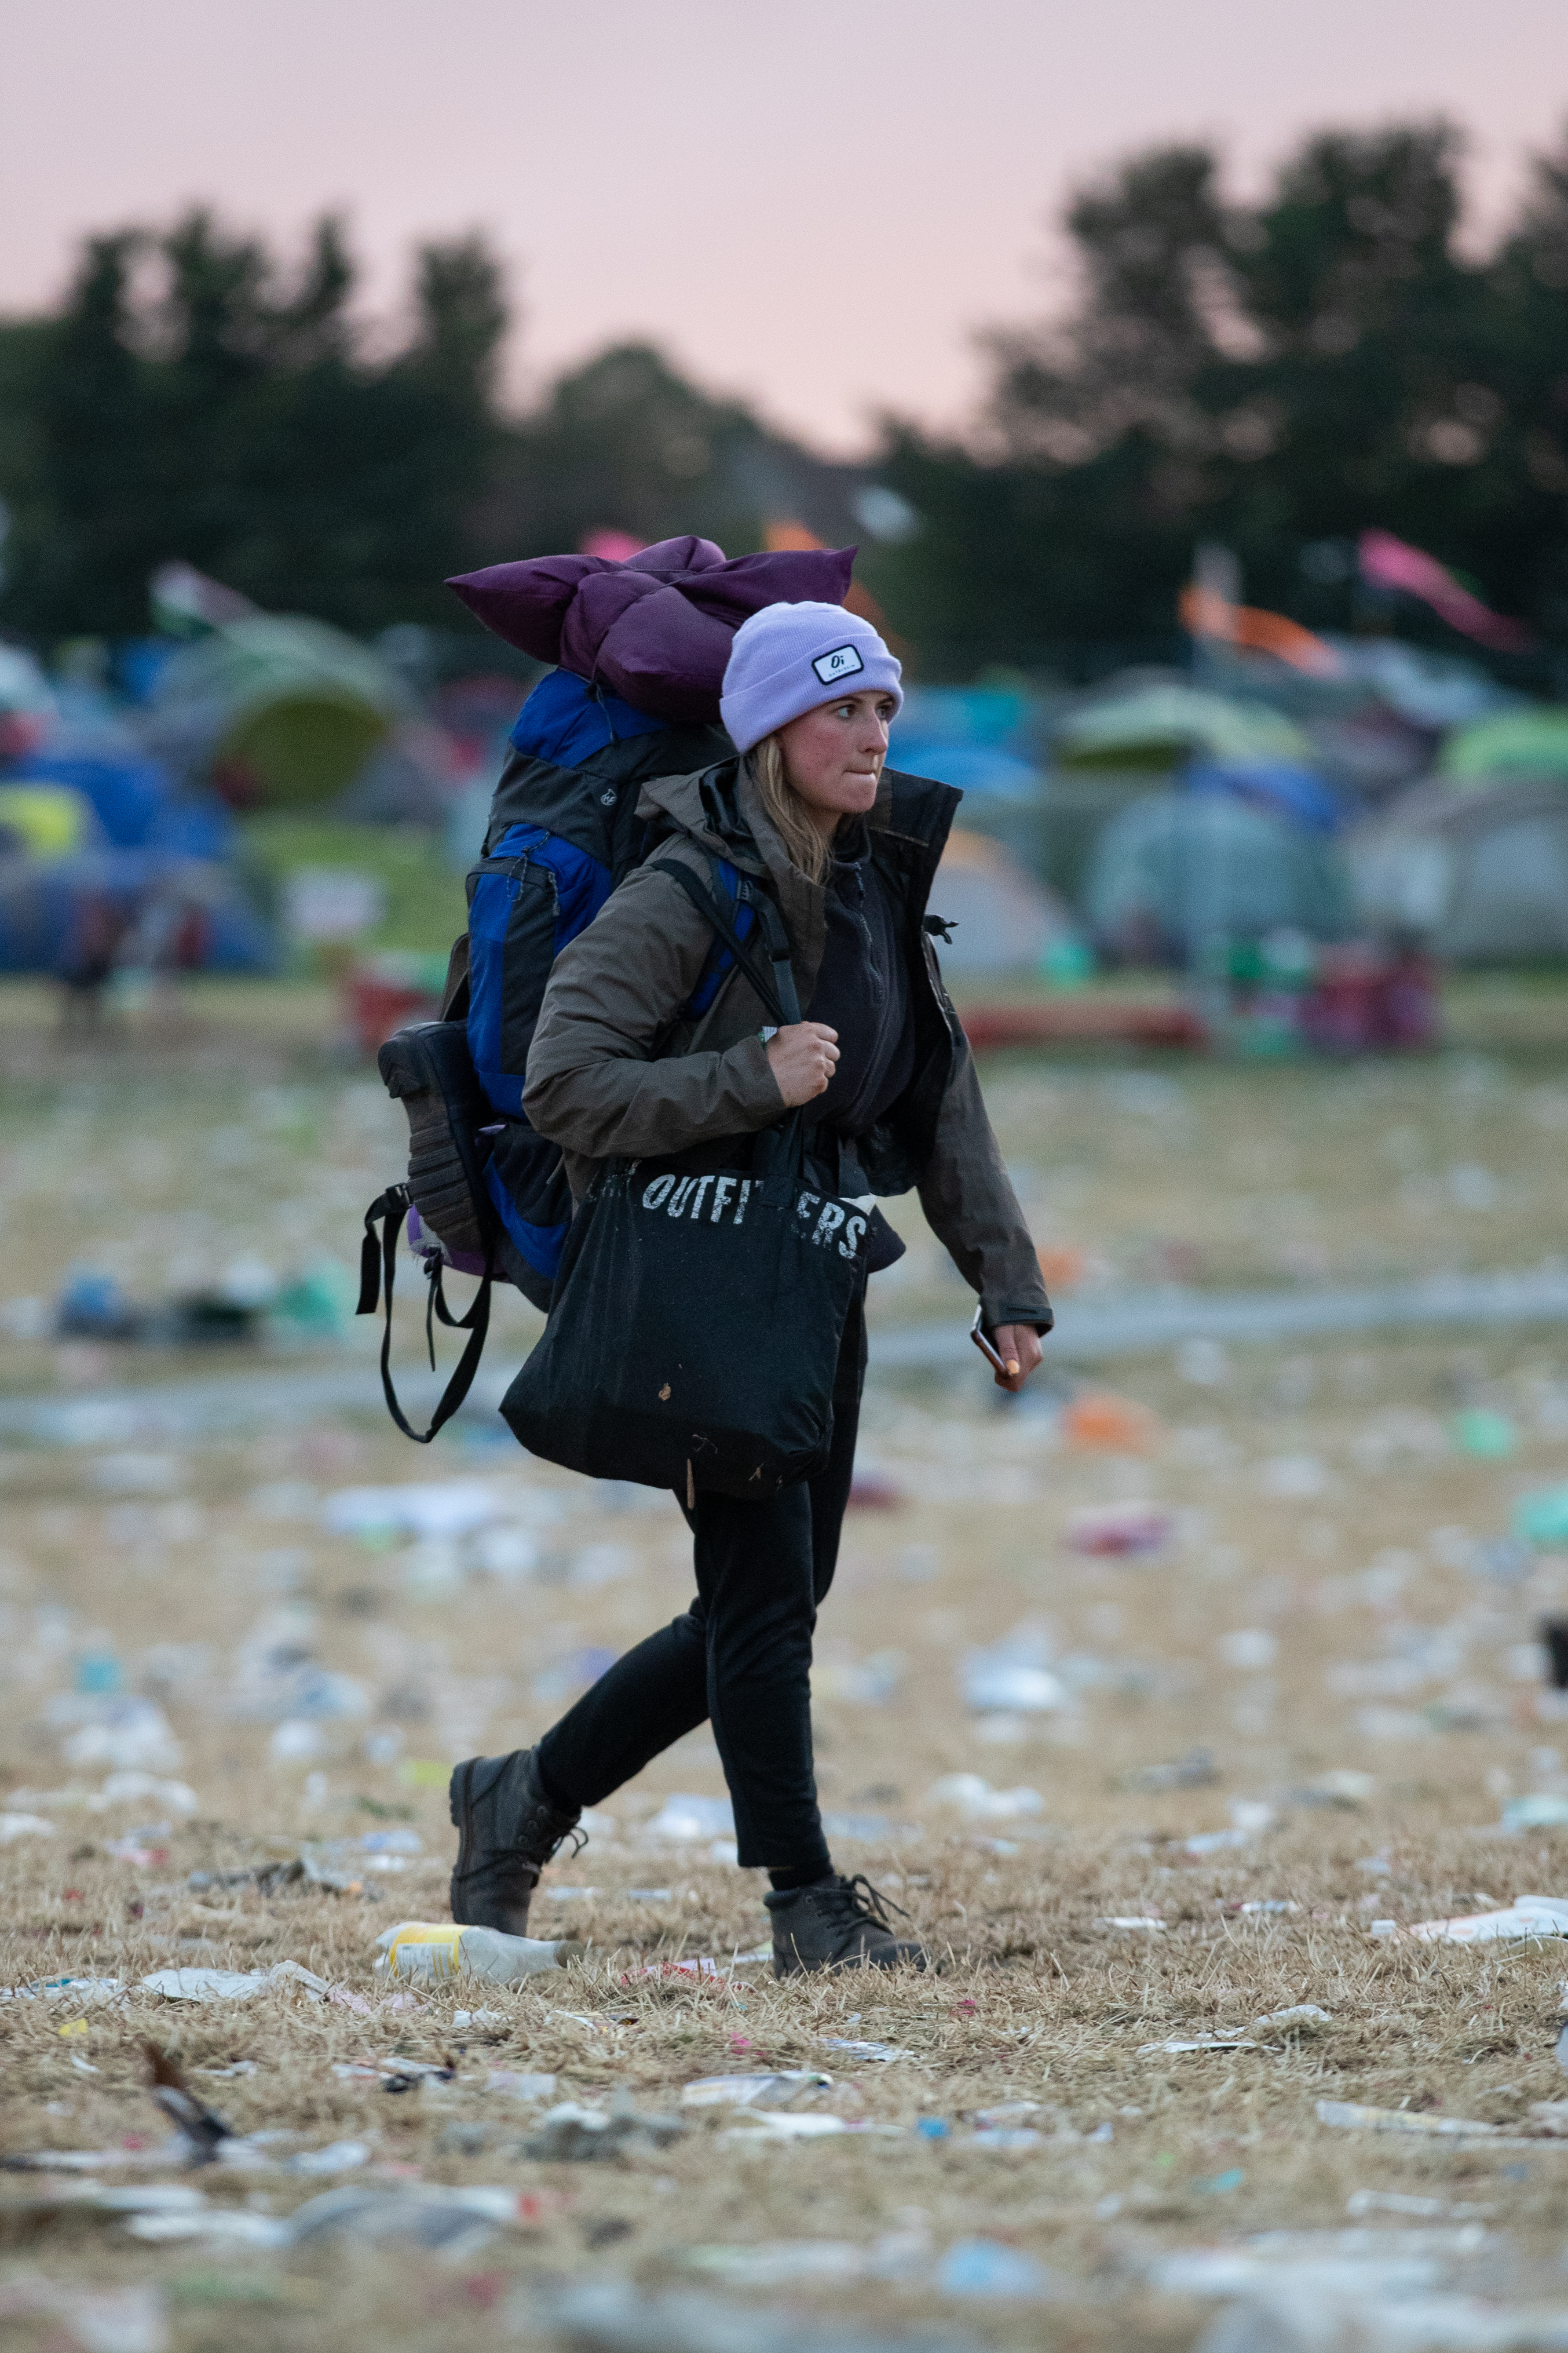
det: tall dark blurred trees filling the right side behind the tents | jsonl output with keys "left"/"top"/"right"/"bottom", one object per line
{"left": 868, "top": 125, "right": 1568, "bottom": 676}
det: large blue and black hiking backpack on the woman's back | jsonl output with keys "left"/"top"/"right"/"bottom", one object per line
{"left": 357, "top": 670, "right": 755, "bottom": 1444}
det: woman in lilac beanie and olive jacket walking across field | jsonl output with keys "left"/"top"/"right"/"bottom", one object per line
{"left": 451, "top": 605, "right": 1051, "bottom": 1976}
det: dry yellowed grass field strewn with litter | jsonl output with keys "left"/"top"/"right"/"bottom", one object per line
{"left": 0, "top": 965, "right": 1568, "bottom": 2353}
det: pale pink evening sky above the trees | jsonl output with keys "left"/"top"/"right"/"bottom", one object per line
{"left": 0, "top": 0, "right": 1568, "bottom": 452}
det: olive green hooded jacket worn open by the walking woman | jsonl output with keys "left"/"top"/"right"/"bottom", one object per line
{"left": 522, "top": 760, "right": 1051, "bottom": 1332}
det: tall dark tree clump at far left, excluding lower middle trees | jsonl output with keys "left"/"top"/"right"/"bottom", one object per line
{"left": 0, "top": 211, "right": 506, "bottom": 638}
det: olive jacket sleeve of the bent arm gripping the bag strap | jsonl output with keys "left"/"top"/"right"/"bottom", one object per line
{"left": 522, "top": 869, "right": 785, "bottom": 1160}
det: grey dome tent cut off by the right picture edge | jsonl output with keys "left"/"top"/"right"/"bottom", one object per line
{"left": 1347, "top": 779, "right": 1568, "bottom": 962}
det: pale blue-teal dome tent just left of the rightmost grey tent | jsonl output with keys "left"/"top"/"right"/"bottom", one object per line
{"left": 1086, "top": 793, "right": 1352, "bottom": 962}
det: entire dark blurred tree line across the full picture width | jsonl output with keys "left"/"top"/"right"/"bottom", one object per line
{"left": 0, "top": 125, "right": 1568, "bottom": 678}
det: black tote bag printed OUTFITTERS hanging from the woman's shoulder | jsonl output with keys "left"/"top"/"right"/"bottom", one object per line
{"left": 500, "top": 861, "right": 870, "bottom": 1504}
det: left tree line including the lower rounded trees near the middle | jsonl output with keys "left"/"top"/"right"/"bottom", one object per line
{"left": 0, "top": 211, "right": 844, "bottom": 640}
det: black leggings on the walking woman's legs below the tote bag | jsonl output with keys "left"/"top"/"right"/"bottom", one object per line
{"left": 538, "top": 1301, "right": 865, "bottom": 1880}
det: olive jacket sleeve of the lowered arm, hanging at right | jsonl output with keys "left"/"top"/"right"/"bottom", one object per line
{"left": 919, "top": 1031, "right": 1055, "bottom": 1332}
